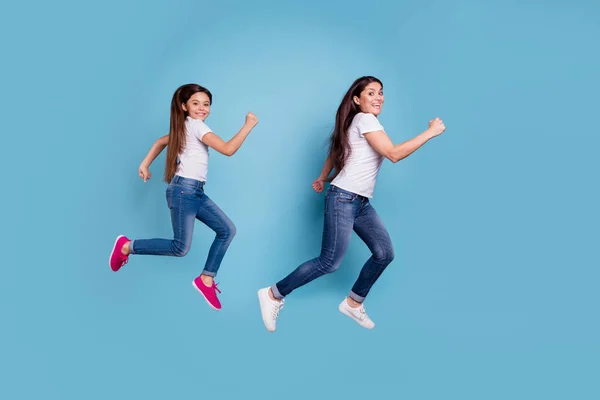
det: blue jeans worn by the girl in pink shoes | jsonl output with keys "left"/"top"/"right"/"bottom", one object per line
{"left": 129, "top": 175, "right": 235, "bottom": 277}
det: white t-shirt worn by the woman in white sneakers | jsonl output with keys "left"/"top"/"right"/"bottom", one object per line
{"left": 331, "top": 112, "right": 384, "bottom": 198}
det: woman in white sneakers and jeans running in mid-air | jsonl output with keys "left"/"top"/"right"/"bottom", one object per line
{"left": 258, "top": 76, "right": 446, "bottom": 332}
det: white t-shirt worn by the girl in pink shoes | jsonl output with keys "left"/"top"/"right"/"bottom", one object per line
{"left": 175, "top": 116, "right": 212, "bottom": 182}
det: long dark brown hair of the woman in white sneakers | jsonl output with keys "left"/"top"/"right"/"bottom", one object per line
{"left": 329, "top": 76, "right": 383, "bottom": 180}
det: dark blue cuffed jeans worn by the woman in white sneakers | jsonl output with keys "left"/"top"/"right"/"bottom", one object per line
{"left": 271, "top": 185, "right": 394, "bottom": 303}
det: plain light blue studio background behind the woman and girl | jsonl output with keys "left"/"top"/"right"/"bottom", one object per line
{"left": 0, "top": 0, "right": 600, "bottom": 400}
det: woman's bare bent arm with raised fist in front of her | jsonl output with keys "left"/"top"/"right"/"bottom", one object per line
{"left": 365, "top": 118, "right": 446, "bottom": 163}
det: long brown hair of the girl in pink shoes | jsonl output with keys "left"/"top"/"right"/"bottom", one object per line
{"left": 164, "top": 83, "right": 212, "bottom": 183}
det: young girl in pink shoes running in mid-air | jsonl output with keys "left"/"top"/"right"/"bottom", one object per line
{"left": 109, "top": 84, "right": 258, "bottom": 310}
